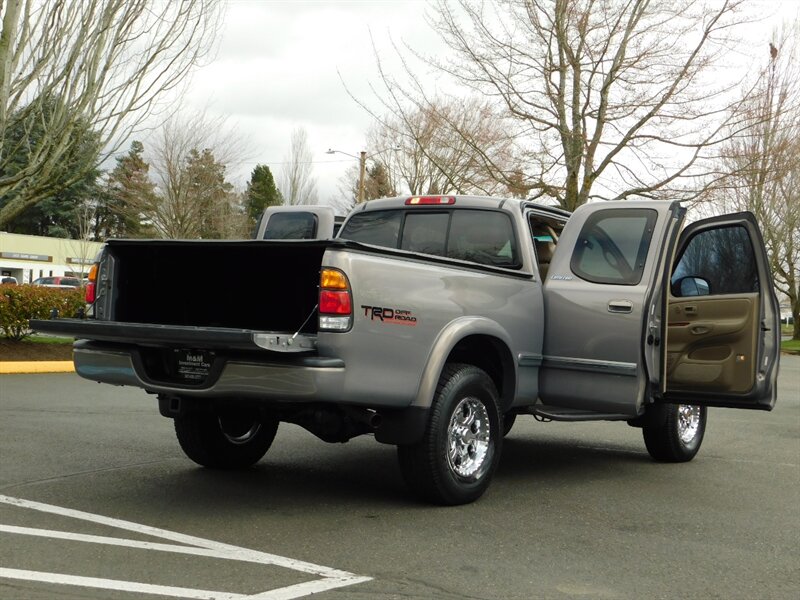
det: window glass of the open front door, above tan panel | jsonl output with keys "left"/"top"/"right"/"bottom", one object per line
{"left": 671, "top": 225, "right": 758, "bottom": 297}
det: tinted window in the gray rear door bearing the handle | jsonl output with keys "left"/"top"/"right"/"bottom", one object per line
{"left": 570, "top": 209, "right": 658, "bottom": 285}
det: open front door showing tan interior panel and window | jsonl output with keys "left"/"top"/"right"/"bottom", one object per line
{"left": 662, "top": 213, "right": 780, "bottom": 410}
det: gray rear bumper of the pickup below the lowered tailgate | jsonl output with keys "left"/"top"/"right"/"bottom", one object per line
{"left": 73, "top": 341, "right": 345, "bottom": 402}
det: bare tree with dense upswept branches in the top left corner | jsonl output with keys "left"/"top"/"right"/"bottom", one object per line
{"left": 0, "top": 0, "right": 220, "bottom": 226}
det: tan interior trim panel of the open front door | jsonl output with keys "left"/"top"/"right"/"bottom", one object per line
{"left": 667, "top": 294, "right": 759, "bottom": 393}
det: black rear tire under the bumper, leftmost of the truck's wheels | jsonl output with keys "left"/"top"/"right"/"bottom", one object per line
{"left": 175, "top": 409, "right": 279, "bottom": 469}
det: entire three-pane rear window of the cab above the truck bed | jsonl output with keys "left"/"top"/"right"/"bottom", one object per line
{"left": 339, "top": 209, "right": 520, "bottom": 268}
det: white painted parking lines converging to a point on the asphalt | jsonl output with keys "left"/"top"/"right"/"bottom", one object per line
{"left": 0, "top": 495, "right": 372, "bottom": 600}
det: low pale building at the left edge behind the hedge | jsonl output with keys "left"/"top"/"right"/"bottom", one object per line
{"left": 0, "top": 231, "right": 102, "bottom": 283}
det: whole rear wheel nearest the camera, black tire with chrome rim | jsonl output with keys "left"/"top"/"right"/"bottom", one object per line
{"left": 397, "top": 364, "right": 503, "bottom": 505}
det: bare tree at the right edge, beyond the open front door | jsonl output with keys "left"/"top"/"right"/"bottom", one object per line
{"left": 718, "top": 29, "right": 800, "bottom": 340}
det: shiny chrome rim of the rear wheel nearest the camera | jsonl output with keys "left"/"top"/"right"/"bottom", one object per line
{"left": 447, "top": 397, "right": 491, "bottom": 479}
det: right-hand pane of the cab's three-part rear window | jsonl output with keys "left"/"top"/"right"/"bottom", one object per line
{"left": 447, "top": 210, "right": 519, "bottom": 268}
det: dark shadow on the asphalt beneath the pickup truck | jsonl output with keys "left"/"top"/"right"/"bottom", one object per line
{"left": 90, "top": 437, "right": 652, "bottom": 516}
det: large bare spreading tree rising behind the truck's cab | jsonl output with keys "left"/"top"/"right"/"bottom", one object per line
{"left": 366, "top": 0, "right": 742, "bottom": 210}
